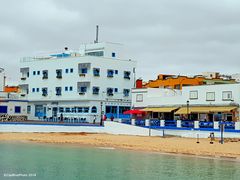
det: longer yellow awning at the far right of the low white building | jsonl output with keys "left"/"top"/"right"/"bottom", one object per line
{"left": 175, "top": 106, "right": 237, "bottom": 114}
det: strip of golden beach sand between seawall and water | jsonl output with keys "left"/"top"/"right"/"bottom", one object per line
{"left": 0, "top": 133, "right": 240, "bottom": 160}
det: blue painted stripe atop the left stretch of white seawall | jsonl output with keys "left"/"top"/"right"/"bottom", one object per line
{"left": 0, "top": 122, "right": 103, "bottom": 127}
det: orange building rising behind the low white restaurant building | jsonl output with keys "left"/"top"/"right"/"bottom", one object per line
{"left": 143, "top": 74, "right": 236, "bottom": 89}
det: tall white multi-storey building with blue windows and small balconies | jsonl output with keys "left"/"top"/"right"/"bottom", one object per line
{"left": 20, "top": 43, "right": 136, "bottom": 122}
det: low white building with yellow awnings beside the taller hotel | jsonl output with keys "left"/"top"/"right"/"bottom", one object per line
{"left": 132, "top": 84, "right": 240, "bottom": 121}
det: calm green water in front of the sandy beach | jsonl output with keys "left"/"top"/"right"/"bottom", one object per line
{"left": 0, "top": 142, "right": 240, "bottom": 180}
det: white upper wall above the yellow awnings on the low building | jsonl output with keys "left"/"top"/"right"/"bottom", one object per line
{"left": 132, "top": 84, "right": 240, "bottom": 107}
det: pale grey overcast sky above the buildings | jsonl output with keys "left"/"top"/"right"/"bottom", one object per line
{"left": 0, "top": 0, "right": 240, "bottom": 85}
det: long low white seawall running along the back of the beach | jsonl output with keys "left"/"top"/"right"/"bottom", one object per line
{"left": 0, "top": 121, "right": 240, "bottom": 138}
